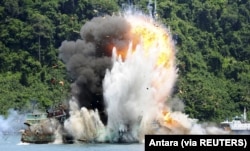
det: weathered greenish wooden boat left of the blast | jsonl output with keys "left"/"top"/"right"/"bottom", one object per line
{"left": 21, "top": 106, "right": 72, "bottom": 144}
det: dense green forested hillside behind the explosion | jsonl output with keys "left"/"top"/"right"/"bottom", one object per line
{"left": 0, "top": 0, "right": 250, "bottom": 121}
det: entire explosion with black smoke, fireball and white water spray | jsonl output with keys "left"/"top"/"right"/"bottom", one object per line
{"left": 59, "top": 9, "right": 228, "bottom": 142}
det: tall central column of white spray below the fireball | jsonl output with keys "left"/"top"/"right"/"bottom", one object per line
{"left": 103, "top": 37, "right": 177, "bottom": 142}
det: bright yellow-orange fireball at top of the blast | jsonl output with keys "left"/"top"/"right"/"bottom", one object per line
{"left": 113, "top": 16, "right": 175, "bottom": 68}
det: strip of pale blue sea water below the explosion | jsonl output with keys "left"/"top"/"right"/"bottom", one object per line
{"left": 0, "top": 134, "right": 144, "bottom": 151}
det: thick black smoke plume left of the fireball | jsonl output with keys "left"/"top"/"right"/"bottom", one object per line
{"left": 59, "top": 16, "right": 130, "bottom": 123}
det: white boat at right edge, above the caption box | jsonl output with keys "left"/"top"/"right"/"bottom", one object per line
{"left": 220, "top": 108, "right": 250, "bottom": 134}
